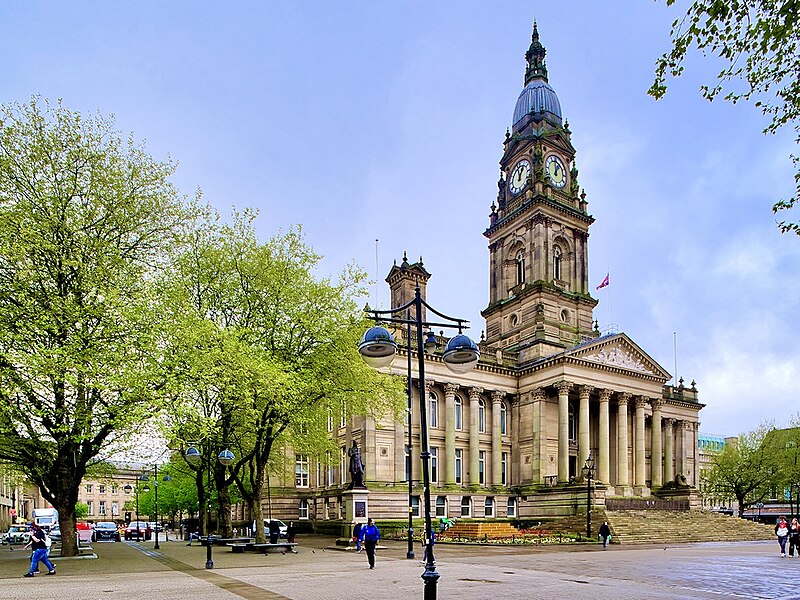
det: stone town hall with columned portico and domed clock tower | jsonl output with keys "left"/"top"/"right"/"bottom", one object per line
{"left": 262, "top": 25, "right": 703, "bottom": 522}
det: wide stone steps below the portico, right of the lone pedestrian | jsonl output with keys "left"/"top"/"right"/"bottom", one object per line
{"left": 608, "top": 510, "right": 775, "bottom": 544}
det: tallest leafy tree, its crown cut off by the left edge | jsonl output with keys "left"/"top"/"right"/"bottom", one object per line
{"left": 0, "top": 98, "right": 189, "bottom": 556}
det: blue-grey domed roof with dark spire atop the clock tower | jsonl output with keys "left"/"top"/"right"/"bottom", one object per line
{"left": 512, "top": 21, "right": 561, "bottom": 132}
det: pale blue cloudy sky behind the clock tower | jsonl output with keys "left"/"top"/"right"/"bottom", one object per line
{"left": 0, "top": 0, "right": 800, "bottom": 435}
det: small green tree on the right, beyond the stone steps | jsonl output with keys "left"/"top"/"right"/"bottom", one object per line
{"left": 703, "top": 425, "right": 778, "bottom": 518}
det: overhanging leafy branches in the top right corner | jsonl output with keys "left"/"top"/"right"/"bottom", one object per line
{"left": 648, "top": 0, "right": 800, "bottom": 235}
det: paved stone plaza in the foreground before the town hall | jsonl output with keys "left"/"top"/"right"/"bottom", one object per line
{"left": 0, "top": 536, "right": 800, "bottom": 600}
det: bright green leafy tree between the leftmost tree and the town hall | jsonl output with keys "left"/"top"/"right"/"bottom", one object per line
{"left": 167, "top": 212, "right": 403, "bottom": 540}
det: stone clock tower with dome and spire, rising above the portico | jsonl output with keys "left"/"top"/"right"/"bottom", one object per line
{"left": 482, "top": 23, "right": 597, "bottom": 363}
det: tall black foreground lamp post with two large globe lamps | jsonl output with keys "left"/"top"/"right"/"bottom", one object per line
{"left": 358, "top": 286, "right": 481, "bottom": 600}
